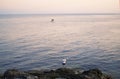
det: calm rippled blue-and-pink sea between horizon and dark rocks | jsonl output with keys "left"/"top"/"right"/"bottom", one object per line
{"left": 0, "top": 15, "right": 120, "bottom": 79}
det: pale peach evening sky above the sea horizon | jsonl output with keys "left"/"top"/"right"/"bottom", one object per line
{"left": 0, "top": 0, "right": 120, "bottom": 14}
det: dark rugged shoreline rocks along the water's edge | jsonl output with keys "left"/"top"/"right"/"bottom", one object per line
{"left": 0, "top": 68, "right": 112, "bottom": 79}
